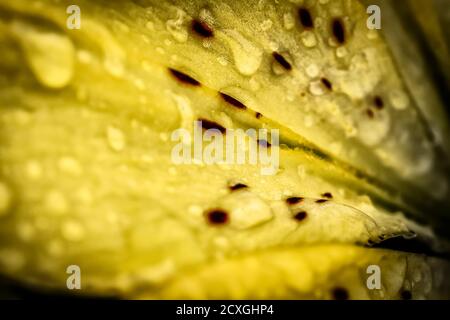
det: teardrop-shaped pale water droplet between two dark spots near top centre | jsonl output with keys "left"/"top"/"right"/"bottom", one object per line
{"left": 224, "top": 30, "right": 263, "bottom": 76}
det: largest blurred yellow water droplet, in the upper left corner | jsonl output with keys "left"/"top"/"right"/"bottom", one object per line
{"left": 12, "top": 22, "right": 75, "bottom": 89}
